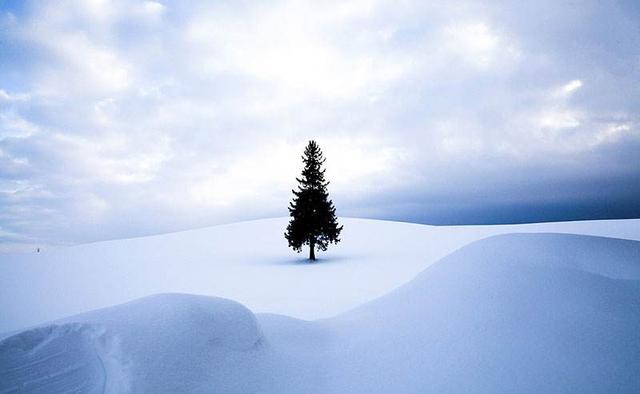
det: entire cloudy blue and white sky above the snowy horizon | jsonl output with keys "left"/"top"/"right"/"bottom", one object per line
{"left": 0, "top": 0, "right": 640, "bottom": 252}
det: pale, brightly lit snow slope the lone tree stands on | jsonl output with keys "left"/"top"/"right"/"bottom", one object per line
{"left": 0, "top": 218, "right": 640, "bottom": 333}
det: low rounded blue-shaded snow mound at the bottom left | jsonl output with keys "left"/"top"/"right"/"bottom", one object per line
{"left": 0, "top": 294, "right": 261, "bottom": 393}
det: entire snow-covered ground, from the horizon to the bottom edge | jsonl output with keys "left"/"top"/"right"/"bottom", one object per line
{"left": 0, "top": 219, "right": 640, "bottom": 393}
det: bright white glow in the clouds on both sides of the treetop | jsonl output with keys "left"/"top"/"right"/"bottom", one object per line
{"left": 191, "top": 137, "right": 401, "bottom": 206}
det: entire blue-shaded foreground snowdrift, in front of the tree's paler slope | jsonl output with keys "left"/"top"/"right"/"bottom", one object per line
{"left": 0, "top": 225, "right": 640, "bottom": 393}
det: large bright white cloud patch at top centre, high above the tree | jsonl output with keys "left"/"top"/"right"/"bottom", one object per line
{"left": 186, "top": 2, "right": 406, "bottom": 102}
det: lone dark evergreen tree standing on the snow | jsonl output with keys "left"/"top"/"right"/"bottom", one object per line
{"left": 284, "top": 140, "right": 342, "bottom": 260}
